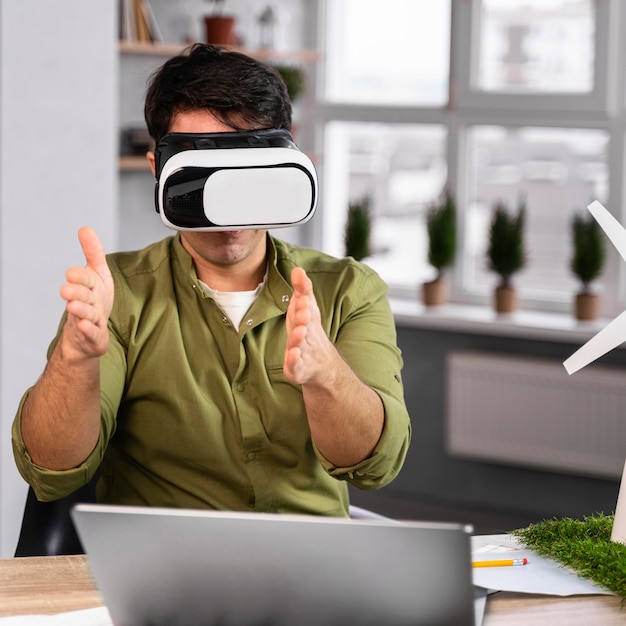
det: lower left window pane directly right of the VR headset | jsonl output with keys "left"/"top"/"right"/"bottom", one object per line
{"left": 324, "top": 122, "right": 447, "bottom": 289}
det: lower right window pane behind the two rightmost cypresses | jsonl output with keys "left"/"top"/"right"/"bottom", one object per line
{"left": 463, "top": 126, "right": 609, "bottom": 302}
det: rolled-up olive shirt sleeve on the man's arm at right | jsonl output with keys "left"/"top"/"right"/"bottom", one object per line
{"left": 315, "top": 265, "right": 411, "bottom": 490}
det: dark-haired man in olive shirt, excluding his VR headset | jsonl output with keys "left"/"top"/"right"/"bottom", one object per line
{"left": 13, "top": 44, "right": 410, "bottom": 515}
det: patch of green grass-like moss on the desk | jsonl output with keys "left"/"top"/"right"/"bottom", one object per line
{"left": 511, "top": 513, "right": 626, "bottom": 600}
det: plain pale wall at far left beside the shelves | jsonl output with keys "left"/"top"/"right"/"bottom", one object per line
{"left": 0, "top": 0, "right": 118, "bottom": 557}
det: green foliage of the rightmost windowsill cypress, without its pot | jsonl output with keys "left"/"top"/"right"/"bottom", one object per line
{"left": 570, "top": 214, "right": 606, "bottom": 293}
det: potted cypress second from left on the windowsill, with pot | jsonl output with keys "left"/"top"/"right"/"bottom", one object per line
{"left": 422, "top": 188, "right": 456, "bottom": 306}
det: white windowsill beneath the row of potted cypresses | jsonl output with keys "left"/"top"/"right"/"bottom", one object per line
{"left": 390, "top": 298, "right": 611, "bottom": 344}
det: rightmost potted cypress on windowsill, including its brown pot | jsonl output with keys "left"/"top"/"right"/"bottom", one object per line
{"left": 570, "top": 214, "right": 606, "bottom": 321}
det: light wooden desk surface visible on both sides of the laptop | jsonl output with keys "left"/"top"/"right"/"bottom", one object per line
{"left": 0, "top": 556, "right": 626, "bottom": 626}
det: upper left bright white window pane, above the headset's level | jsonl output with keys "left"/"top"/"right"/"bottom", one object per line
{"left": 325, "top": 0, "right": 450, "bottom": 106}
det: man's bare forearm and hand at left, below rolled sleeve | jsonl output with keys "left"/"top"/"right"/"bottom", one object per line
{"left": 21, "top": 228, "right": 114, "bottom": 470}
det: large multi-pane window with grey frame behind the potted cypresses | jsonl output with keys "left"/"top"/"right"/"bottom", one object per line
{"left": 319, "top": 0, "right": 626, "bottom": 314}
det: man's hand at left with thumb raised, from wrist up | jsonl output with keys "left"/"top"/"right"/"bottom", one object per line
{"left": 61, "top": 227, "right": 114, "bottom": 359}
